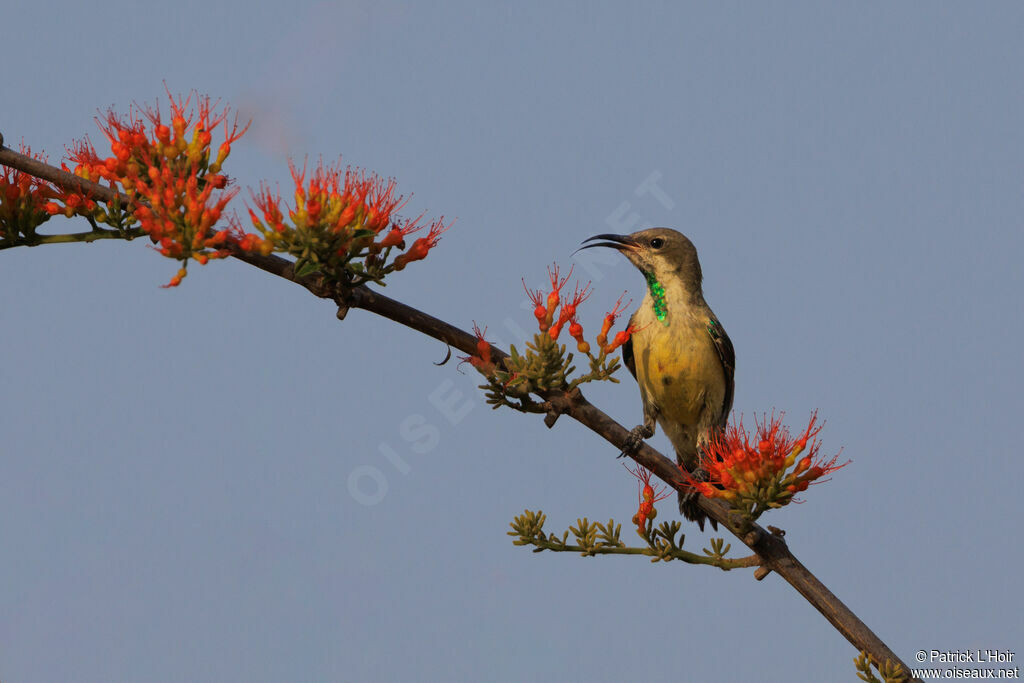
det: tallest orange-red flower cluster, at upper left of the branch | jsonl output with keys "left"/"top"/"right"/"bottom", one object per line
{"left": 46, "top": 93, "right": 248, "bottom": 287}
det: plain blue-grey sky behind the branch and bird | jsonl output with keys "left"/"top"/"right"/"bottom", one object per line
{"left": 0, "top": 0, "right": 1024, "bottom": 683}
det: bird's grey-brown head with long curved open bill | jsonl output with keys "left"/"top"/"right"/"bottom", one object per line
{"left": 580, "top": 227, "right": 701, "bottom": 293}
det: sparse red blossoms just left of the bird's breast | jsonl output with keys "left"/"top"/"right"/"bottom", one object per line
{"left": 523, "top": 265, "right": 636, "bottom": 355}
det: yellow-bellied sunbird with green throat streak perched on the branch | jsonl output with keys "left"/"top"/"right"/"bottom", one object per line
{"left": 582, "top": 227, "right": 736, "bottom": 530}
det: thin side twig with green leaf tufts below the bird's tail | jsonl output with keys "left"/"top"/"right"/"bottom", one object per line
{"left": 508, "top": 510, "right": 758, "bottom": 570}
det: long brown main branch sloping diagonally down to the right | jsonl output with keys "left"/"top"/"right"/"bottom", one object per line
{"left": 0, "top": 135, "right": 919, "bottom": 681}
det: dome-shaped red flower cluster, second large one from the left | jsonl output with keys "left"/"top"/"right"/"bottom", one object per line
{"left": 240, "top": 158, "right": 449, "bottom": 279}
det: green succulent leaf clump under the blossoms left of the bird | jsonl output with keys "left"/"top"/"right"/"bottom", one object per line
{"left": 480, "top": 332, "right": 620, "bottom": 413}
